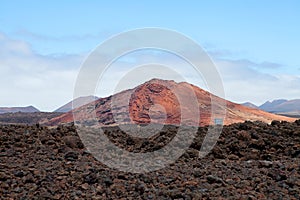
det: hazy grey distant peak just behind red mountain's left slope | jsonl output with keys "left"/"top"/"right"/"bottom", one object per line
{"left": 54, "top": 96, "right": 98, "bottom": 113}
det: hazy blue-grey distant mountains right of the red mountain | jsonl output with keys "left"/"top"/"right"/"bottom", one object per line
{"left": 242, "top": 99, "right": 300, "bottom": 117}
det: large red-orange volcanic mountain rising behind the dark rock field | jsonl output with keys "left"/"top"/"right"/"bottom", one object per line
{"left": 45, "top": 79, "right": 295, "bottom": 126}
